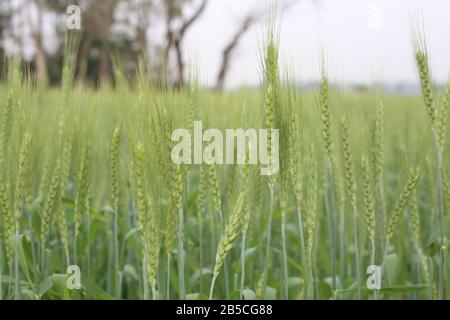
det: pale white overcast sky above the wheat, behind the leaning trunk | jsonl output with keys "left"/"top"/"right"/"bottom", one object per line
{"left": 184, "top": 0, "right": 450, "bottom": 87}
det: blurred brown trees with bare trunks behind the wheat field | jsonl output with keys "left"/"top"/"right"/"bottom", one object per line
{"left": 0, "top": 0, "right": 315, "bottom": 89}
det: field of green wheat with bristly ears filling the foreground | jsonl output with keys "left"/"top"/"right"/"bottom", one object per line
{"left": 0, "top": 25, "right": 450, "bottom": 300}
